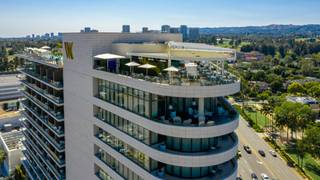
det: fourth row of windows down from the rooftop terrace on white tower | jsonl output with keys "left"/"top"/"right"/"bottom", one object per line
{"left": 96, "top": 146, "right": 143, "bottom": 180}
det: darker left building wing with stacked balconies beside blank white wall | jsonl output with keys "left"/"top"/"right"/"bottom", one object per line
{"left": 18, "top": 48, "right": 65, "bottom": 179}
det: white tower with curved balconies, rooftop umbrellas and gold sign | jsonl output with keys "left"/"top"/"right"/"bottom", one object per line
{"left": 62, "top": 33, "right": 240, "bottom": 180}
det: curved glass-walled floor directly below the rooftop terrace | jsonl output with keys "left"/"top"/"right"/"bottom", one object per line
{"left": 96, "top": 79, "right": 238, "bottom": 126}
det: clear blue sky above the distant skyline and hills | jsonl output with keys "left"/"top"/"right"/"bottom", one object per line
{"left": 0, "top": 0, "right": 320, "bottom": 37}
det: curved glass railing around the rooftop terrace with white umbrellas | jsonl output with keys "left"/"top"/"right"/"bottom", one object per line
{"left": 94, "top": 60, "right": 238, "bottom": 86}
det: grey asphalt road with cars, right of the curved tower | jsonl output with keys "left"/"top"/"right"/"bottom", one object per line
{"left": 237, "top": 116, "right": 303, "bottom": 180}
